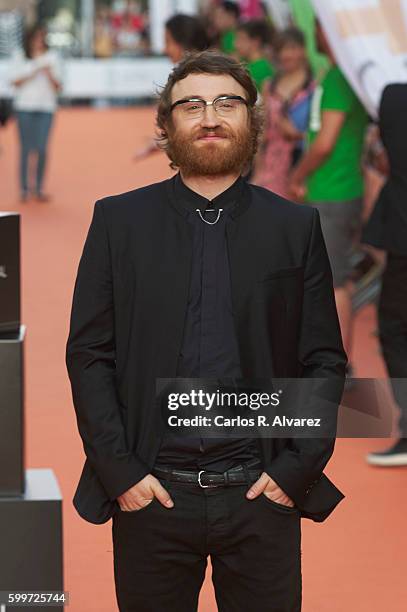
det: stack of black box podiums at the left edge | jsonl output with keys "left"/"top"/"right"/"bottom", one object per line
{"left": 0, "top": 212, "right": 64, "bottom": 612}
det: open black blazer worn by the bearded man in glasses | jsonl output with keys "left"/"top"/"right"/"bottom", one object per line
{"left": 66, "top": 177, "right": 346, "bottom": 523}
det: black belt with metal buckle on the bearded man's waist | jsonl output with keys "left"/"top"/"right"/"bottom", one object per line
{"left": 151, "top": 460, "right": 263, "bottom": 489}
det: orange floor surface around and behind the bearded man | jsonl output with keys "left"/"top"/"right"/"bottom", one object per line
{"left": 0, "top": 108, "right": 407, "bottom": 612}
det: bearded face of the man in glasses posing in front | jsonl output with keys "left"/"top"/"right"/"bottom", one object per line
{"left": 168, "top": 74, "right": 251, "bottom": 176}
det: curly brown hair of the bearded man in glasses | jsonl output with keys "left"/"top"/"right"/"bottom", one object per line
{"left": 155, "top": 50, "right": 264, "bottom": 170}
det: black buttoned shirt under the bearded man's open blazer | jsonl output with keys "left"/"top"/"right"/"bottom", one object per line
{"left": 155, "top": 173, "right": 260, "bottom": 472}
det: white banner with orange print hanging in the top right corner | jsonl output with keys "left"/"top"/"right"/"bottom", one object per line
{"left": 312, "top": 0, "right": 407, "bottom": 117}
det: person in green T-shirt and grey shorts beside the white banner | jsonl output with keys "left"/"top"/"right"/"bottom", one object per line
{"left": 290, "top": 23, "right": 368, "bottom": 376}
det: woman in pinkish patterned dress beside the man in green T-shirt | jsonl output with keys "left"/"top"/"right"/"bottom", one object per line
{"left": 251, "top": 28, "right": 315, "bottom": 197}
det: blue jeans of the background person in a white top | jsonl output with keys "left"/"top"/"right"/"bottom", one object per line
{"left": 16, "top": 111, "right": 54, "bottom": 193}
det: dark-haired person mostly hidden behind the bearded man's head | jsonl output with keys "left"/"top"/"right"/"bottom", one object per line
{"left": 133, "top": 13, "right": 210, "bottom": 161}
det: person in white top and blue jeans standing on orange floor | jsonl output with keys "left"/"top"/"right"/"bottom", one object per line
{"left": 10, "top": 25, "right": 61, "bottom": 202}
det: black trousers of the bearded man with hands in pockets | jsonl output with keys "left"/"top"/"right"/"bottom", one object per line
{"left": 112, "top": 468, "right": 302, "bottom": 612}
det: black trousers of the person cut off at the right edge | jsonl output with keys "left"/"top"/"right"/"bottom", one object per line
{"left": 378, "top": 253, "right": 407, "bottom": 438}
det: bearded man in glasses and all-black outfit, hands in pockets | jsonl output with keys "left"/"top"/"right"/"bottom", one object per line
{"left": 66, "top": 51, "right": 346, "bottom": 612}
